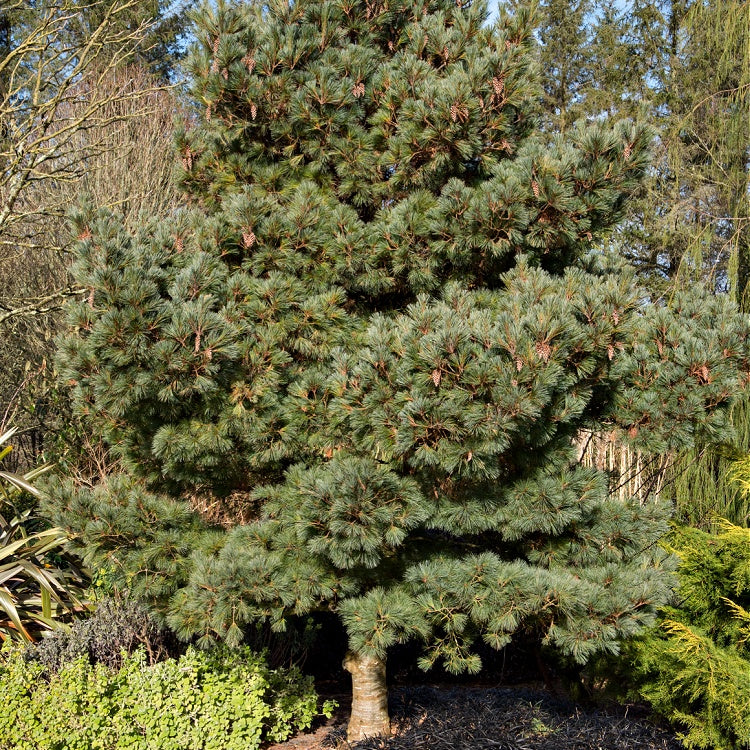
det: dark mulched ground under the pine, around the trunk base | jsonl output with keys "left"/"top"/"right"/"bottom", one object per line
{"left": 278, "top": 686, "right": 683, "bottom": 750}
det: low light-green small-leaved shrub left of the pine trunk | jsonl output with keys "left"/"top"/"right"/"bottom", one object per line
{"left": 0, "top": 647, "right": 331, "bottom": 750}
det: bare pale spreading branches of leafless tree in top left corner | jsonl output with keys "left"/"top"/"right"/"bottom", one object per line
{"left": 0, "top": 0, "right": 166, "bottom": 235}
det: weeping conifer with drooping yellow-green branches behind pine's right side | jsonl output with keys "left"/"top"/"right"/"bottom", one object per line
{"left": 643, "top": 2, "right": 750, "bottom": 526}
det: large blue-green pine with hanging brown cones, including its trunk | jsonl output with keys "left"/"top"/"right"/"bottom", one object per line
{"left": 56, "top": 0, "right": 749, "bottom": 738}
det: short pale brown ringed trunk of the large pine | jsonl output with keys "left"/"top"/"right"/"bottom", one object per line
{"left": 344, "top": 651, "right": 391, "bottom": 742}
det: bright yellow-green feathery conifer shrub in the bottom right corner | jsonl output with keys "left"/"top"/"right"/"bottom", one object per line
{"left": 620, "top": 522, "right": 750, "bottom": 750}
